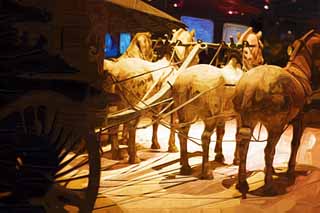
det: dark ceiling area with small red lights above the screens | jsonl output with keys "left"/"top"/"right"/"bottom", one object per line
{"left": 144, "top": 0, "right": 320, "bottom": 66}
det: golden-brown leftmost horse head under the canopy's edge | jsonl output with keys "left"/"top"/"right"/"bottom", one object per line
{"left": 121, "top": 32, "right": 153, "bottom": 61}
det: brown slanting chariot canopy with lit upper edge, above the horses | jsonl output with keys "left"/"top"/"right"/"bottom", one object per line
{"left": 91, "top": 0, "right": 186, "bottom": 32}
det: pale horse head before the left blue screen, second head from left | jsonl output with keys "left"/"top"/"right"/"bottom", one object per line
{"left": 171, "top": 28, "right": 199, "bottom": 65}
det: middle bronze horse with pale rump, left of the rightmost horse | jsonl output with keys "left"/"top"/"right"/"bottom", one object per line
{"left": 172, "top": 27, "right": 263, "bottom": 179}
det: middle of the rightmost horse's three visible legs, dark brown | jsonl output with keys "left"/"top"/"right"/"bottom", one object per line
{"left": 264, "top": 126, "right": 283, "bottom": 195}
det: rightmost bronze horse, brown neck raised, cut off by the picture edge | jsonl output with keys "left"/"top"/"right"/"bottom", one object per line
{"left": 233, "top": 30, "right": 320, "bottom": 198}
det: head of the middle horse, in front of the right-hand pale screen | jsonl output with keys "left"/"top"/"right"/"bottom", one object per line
{"left": 238, "top": 27, "right": 264, "bottom": 70}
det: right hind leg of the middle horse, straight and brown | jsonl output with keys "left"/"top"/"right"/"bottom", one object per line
{"left": 201, "top": 122, "right": 216, "bottom": 179}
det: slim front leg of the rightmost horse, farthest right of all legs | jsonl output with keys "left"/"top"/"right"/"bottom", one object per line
{"left": 287, "top": 117, "right": 304, "bottom": 183}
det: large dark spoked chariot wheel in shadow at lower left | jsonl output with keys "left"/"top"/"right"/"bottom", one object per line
{"left": 0, "top": 93, "right": 100, "bottom": 213}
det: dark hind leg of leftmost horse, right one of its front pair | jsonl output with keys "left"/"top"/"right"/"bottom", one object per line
{"left": 128, "top": 118, "right": 140, "bottom": 164}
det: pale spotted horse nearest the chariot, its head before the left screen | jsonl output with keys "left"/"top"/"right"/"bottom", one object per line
{"left": 105, "top": 29, "right": 198, "bottom": 163}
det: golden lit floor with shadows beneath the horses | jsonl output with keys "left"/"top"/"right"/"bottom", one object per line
{"left": 94, "top": 122, "right": 320, "bottom": 213}
